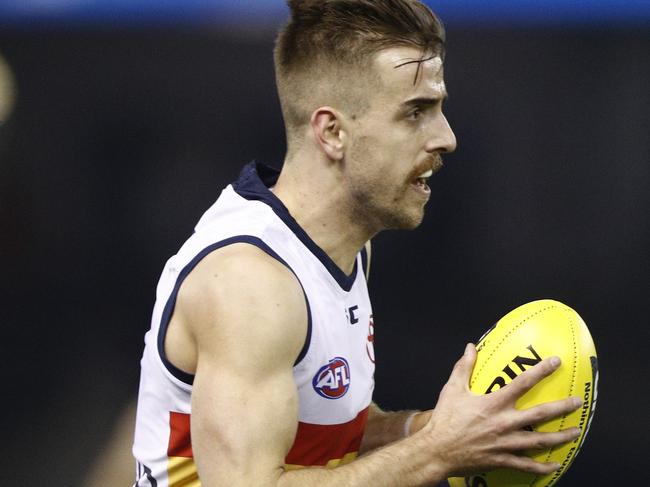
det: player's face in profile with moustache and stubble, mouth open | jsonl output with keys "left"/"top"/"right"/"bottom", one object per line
{"left": 344, "top": 47, "right": 456, "bottom": 231}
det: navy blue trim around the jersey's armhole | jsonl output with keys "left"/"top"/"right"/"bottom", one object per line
{"left": 158, "top": 235, "right": 312, "bottom": 385}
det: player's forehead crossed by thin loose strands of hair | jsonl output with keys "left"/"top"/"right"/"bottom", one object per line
{"left": 375, "top": 47, "right": 447, "bottom": 97}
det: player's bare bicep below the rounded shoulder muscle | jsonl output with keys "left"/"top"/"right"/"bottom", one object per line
{"left": 192, "top": 354, "right": 298, "bottom": 486}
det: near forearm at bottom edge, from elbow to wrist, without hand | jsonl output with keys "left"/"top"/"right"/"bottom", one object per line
{"left": 277, "top": 437, "right": 446, "bottom": 487}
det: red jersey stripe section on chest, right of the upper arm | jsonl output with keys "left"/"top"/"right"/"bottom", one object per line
{"left": 285, "top": 408, "right": 368, "bottom": 466}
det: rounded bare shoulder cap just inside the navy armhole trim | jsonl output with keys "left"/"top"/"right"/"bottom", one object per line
{"left": 177, "top": 242, "right": 307, "bottom": 358}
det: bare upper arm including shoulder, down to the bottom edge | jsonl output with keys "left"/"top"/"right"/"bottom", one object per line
{"left": 178, "top": 247, "right": 307, "bottom": 487}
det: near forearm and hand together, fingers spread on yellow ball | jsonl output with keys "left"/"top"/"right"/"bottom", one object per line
{"left": 279, "top": 345, "right": 579, "bottom": 487}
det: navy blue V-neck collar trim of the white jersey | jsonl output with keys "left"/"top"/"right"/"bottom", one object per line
{"left": 232, "top": 161, "right": 357, "bottom": 291}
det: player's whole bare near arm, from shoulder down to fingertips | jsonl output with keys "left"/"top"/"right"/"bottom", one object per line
{"left": 175, "top": 244, "right": 575, "bottom": 487}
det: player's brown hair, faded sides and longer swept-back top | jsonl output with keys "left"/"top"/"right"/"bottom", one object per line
{"left": 274, "top": 0, "right": 445, "bottom": 142}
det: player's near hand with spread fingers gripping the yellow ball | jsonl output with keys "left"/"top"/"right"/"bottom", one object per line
{"left": 420, "top": 344, "right": 581, "bottom": 476}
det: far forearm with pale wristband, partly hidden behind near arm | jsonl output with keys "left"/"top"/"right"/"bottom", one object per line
{"left": 360, "top": 403, "right": 431, "bottom": 454}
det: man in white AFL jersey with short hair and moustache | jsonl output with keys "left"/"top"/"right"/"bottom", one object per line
{"left": 134, "top": 0, "right": 579, "bottom": 487}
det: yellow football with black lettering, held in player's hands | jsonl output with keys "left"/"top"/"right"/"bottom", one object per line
{"left": 449, "top": 299, "right": 598, "bottom": 487}
